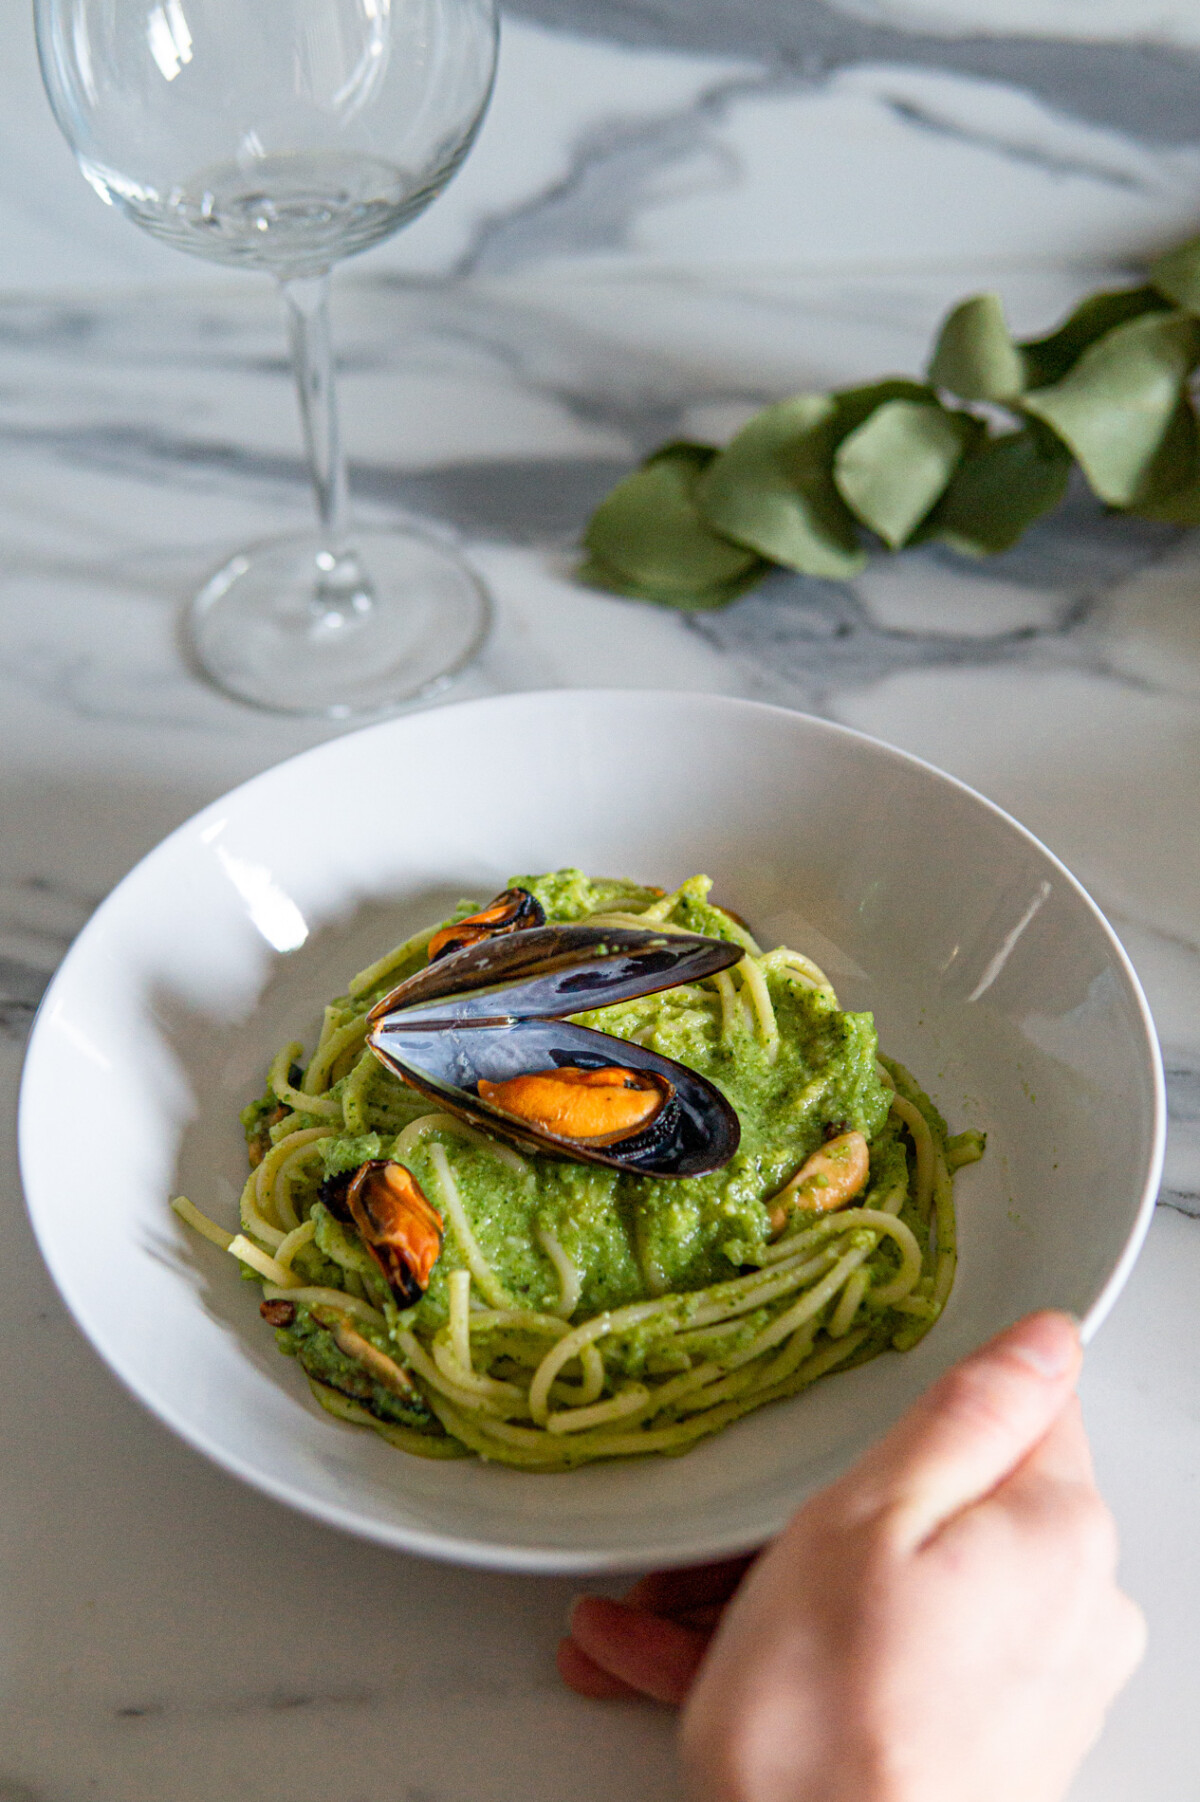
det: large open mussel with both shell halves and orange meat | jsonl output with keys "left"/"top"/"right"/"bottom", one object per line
{"left": 368, "top": 923, "right": 742, "bottom": 1177}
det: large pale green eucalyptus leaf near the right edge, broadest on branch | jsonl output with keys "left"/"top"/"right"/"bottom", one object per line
{"left": 1023, "top": 312, "right": 1200, "bottom": 506}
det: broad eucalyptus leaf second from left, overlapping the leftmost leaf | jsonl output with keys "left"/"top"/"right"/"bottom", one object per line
{"left": 695, "top": 395, "right": 867, "bottom": 577}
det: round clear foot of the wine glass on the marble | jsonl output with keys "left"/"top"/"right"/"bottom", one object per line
{"left": 189, "top": 528, "right": 492, "bottom": 719}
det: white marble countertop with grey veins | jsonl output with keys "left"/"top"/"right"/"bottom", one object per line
{"left": 0, "top": 0, "right": 1200, "bottom": 1802}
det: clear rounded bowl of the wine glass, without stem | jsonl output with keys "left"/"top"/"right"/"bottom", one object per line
{"left": 38, "top": 0, "right": 495, "bottom": 279}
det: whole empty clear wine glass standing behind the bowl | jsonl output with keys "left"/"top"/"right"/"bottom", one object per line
{"left": 34, "top": 0, "right": 497, "bottom": 717}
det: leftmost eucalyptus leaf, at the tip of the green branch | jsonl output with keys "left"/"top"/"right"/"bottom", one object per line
{"left": 584, "top": 441, "right": 760, "bottom": 605}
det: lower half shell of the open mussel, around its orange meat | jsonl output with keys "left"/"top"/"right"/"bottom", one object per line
{"left": 368, "top": 1013, "right": 741, "bottom": 1177}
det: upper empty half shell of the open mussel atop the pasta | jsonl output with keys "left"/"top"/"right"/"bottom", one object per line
{"left": 369, "top": 924, "right": 742, "bottom": 1029}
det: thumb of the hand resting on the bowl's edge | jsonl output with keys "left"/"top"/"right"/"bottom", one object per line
{"left": 836, "top": 1312, "right": 1083, "bottom": 1550}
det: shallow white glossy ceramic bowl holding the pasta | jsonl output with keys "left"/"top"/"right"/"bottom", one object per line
{"left": 20, "top": 692, "right": 1164, "bottom": 1571}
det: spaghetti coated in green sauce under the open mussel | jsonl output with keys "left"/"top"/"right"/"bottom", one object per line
{"left": 173, "top": 870, "right": 984, "bottom": 1472}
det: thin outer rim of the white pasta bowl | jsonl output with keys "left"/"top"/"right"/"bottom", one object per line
{"left": 16, "top": 688, "right": 1168, "bottom": 1575}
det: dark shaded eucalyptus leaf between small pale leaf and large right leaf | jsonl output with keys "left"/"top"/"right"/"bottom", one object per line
{"left": 919, "top": 420, "right": 1070, "bottom": 557}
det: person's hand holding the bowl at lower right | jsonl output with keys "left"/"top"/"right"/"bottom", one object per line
{"left": 564, "top": 1314, "right": 1144, "bottom": 1802}
